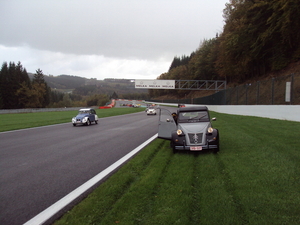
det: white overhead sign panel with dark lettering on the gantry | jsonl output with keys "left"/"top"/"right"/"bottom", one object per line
{"left": 135, "top": 80, "right": 175, "bottom": 89}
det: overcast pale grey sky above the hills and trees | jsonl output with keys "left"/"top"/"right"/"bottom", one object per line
{"left": 0, "top": 0, "right": 229, "bottom": 80}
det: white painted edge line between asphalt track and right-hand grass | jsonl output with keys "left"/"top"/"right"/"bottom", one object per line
{"left": 24, "top": 134, "right": 157, "bottom": 225}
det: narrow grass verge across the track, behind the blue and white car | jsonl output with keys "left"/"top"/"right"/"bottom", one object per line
{"left": 0, "top": 108, "right": 145, "bottom": 132}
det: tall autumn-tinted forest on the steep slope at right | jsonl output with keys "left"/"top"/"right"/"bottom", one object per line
{"left": 149, "top": 0, "right": 300, "bottom": 97}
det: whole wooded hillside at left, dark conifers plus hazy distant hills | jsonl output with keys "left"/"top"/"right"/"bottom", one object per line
{"left": 0, "top": 62, "right": 148, "bottom": 109}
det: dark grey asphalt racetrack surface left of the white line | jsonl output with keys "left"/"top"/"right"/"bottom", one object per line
{"left": 0, "top": 108, "right": 158, "bottom": 225}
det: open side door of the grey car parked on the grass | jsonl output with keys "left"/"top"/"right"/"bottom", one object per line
{"left": 158, "top": 108, "right": 177, "bottom": 140}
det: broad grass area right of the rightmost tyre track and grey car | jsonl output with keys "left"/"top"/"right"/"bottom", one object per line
{"left": 214, "top": 114, "right": 300, "bottom": 224}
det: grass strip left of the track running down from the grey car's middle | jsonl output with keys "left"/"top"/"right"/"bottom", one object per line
{"left": 143, "top": 151, "right": 194, "bottom": 224}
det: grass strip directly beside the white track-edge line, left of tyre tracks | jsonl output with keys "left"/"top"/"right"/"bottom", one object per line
{"left": 55, "top": 140, "right": 171, "bottom": 225}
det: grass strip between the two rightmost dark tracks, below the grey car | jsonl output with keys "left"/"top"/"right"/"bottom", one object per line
{"left": 190, "top": 153, "right": 243, "bottom": 225}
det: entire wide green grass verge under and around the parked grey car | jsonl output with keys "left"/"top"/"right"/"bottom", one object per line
{"left": 55, "top": 113, "right": 300, "bottom": 225}
